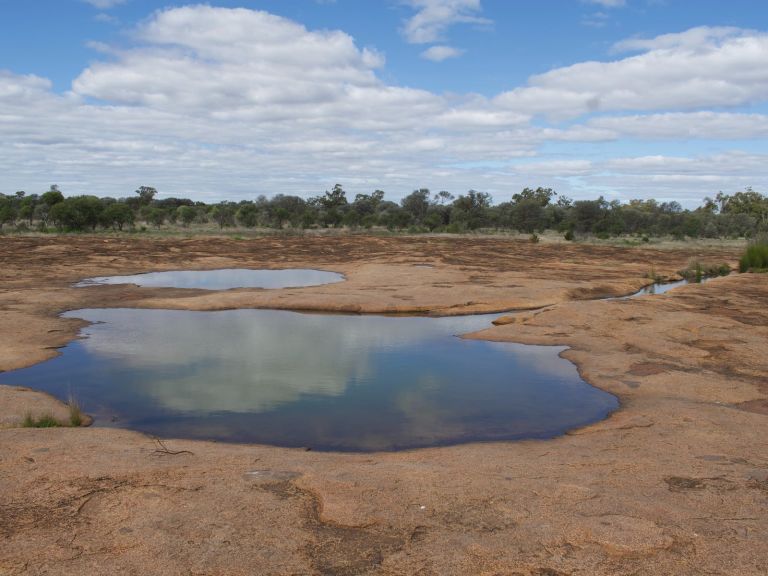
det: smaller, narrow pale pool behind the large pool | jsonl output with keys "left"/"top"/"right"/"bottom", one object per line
{"left": 75, "top": 268, "right": 344, "bottom": 290}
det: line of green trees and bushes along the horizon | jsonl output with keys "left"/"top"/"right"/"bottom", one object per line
{"left": 0, "top": 184, "right": 768, "bottom": 238}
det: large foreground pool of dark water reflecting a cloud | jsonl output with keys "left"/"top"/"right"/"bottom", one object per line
{"left": 0, "top": 309, "right": 618, "bottom": 451}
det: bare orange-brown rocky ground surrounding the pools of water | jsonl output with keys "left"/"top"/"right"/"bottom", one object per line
{"left": 0, "top": 237, "right": 768, "bottom": 576}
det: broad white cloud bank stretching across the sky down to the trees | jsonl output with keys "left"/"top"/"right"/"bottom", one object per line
{"left": 0, "top": 3, "right": 768, "bottom": 204}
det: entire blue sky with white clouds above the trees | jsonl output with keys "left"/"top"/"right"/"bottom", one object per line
{"left": 0, "top": 0, "right": 768, "bottom": 208}
